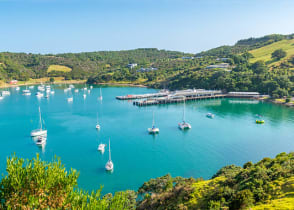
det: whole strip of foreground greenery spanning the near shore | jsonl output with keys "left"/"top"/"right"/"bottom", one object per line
{"left": 0, "top": 153, "right": 294, "bottom": 209}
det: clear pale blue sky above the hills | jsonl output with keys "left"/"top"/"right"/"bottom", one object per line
{"left": 0, "top": 0, "right": 294, "bottom": 53}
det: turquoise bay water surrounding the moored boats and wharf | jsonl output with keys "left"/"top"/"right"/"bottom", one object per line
{"left": 0, "top": 86, "right": 294, "bottom": 193}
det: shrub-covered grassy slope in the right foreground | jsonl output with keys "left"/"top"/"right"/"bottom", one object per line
{"left": 138, "top": 153, "right": 294, "bottom": 209}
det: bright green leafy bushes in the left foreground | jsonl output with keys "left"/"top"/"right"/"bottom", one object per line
{"left": 0, "top": 155, "right": 136, "bottom": 209}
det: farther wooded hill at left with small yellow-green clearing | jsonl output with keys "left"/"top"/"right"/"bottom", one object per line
{"left": 0, "top": 48, "right": 191, "bottom": 81}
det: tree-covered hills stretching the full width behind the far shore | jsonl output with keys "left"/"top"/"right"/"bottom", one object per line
{"left": 0, "top": 34, "right": 294, "bottom": 98}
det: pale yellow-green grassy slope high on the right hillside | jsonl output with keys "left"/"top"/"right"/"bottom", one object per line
{"left": 249, "top": 39, "right": 294, "bottom": 66}
